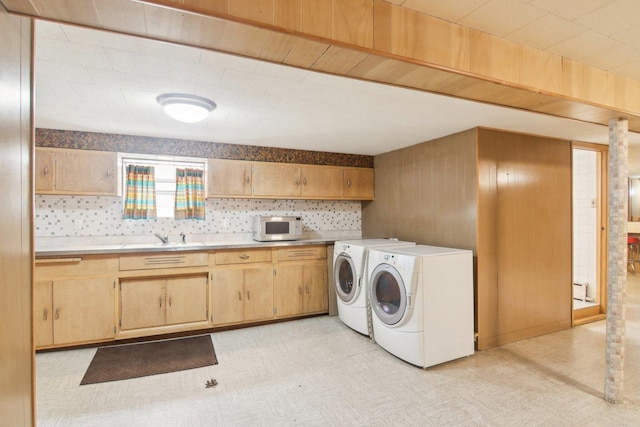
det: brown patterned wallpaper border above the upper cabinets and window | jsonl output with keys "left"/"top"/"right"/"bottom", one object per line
{"left": 36, "top": 128, "right": 373, "bottom": 168}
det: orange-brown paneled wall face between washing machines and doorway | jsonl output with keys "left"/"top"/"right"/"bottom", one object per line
{"left": 476, "top": 129, "right": 572, "bottom": 350}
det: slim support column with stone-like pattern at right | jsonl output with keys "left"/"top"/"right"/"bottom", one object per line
{"left": 604, "top": 119, "right": 629, "bottom": 403}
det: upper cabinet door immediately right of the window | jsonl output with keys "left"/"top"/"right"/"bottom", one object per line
{"left": 207, "top": 159, "right": 251, "bottom": 197}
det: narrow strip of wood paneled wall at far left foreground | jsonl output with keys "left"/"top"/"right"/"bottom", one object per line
{"left": 0, "top": 5, "right": 35, "bottom": 426}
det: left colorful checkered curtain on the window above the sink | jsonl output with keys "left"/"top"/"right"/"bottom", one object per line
{"left": 123, "top": 165, "right": 157, "bottom": 219}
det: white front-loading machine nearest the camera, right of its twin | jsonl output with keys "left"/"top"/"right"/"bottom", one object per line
{"left": 367, "top": 245, "right": 475, "bottom": 368}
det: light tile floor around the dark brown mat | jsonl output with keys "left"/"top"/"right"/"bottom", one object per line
{"left": 36, "top": 275, "right": 640, "bottom": 427}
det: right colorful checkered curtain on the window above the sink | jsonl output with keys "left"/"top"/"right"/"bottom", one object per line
{"left": 174, "top": 168, "right": 205, "bottom": 219}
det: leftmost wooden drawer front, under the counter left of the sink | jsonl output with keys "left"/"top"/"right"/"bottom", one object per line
{"left": 34, "top": 255, "right": 118, "bottom": 280}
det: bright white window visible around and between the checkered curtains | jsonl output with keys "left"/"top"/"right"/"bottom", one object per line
{"left": 118, "top": 153, "right": 206, "bottom": 218}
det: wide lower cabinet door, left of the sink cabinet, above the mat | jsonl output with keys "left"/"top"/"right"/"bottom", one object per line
{"left": 53, "top": 278, "right": 115, "bottom": 344}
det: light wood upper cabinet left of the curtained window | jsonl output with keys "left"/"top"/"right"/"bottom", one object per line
{"left": 36, "top": 148, "right": 117, "bottom": 196}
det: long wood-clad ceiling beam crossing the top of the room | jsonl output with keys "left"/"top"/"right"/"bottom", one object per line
{"left": 5, "top": 0, "right": 640, "bottom": 131}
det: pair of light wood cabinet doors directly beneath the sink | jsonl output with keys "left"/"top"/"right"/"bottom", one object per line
{"left": 120, "top": 275, "right": 208, "bottom": 331}
